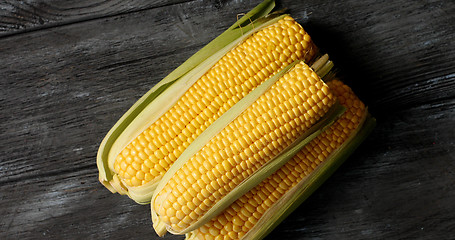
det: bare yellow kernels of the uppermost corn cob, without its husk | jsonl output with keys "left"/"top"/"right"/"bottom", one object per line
{"left": 114, "top": 17, "right": 316, "bottom": 191}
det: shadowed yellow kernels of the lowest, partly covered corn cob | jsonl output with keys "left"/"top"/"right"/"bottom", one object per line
{"left": 187, "top": 80, "right": 366, "bottom": 240}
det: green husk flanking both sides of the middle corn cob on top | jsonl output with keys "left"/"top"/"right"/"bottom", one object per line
{"left": 151, "top": 55, "right": 345, "bottom": 236}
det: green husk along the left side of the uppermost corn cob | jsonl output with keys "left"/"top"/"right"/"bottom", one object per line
{"left": 97, "top": 0, "right": 286, "bottom": 204}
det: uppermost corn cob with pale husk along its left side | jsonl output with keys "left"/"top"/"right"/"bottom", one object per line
{"left": 98, "top": 0, "right": 316, "bottom": 203}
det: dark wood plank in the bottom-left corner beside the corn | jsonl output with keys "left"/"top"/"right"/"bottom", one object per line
{"left": 0, "top": 168, "right": 159, "bottom": 239}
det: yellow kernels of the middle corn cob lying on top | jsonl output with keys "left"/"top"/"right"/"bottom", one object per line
{"left": 152, "top": 63, "right": 335, "bottom": 234}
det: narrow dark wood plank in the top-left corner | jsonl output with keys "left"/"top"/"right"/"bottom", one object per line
{"left": 0, "top": 0, "right": 190, "bottom": 37}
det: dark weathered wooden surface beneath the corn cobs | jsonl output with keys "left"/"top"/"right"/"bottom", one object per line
{"left": 0, "top": 0, "right": 455, "bottom": 239}
